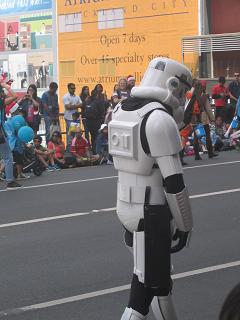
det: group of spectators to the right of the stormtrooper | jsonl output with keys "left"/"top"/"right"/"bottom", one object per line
{"left": 180, "top": 72, "right": 240, "bottom": 164}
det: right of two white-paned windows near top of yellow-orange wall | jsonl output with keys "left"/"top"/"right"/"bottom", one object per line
{"left": 98, "top": 8, "right": 124, "bottom": 30}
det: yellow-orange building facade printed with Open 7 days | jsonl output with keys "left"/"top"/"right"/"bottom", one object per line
{"left": 57, "top": 0, "right": 199, "bottom": 101}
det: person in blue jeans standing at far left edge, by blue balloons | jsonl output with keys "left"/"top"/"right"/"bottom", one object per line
{"left": 0, "top": 80, "right": 22, "bottom": 189}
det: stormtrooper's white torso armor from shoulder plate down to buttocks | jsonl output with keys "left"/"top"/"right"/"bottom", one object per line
{"left": 109, "top": 102, "right": 182, "bottom": 231}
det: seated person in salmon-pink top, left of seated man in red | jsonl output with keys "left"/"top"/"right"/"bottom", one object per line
{"left": 48, "top": 131, "right": 65, "bottom": 170}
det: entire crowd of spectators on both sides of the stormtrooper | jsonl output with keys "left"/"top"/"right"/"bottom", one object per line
{"left": 0, "top": 69, "right": 240, "bottom": 188}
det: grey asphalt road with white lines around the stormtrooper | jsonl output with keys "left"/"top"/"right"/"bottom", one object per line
{"left": 0, "top": 151, "right": 240, "bottom": 320}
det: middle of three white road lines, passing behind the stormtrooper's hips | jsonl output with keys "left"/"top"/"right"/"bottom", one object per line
{"left": 0, "top": 188, "right": 240, "bottom": 228}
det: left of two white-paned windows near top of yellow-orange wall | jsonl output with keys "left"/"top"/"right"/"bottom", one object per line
{"left": 58, "top": 12, "right": 82, "bottom": 32}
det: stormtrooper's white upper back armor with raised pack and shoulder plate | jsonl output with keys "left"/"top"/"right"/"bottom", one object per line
{"left": 109, "top": 102, "right": 182, "bottom": 175}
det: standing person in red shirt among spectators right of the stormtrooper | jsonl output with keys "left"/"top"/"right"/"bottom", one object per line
{"left": 212, "top": 77, "right": 229, "bottom": 121}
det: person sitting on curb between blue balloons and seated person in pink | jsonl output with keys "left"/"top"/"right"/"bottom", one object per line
{"left": 32, "top": 135, "right": 54, "bottom": 171}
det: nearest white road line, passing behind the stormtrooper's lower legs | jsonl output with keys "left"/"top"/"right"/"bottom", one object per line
{"left": 0, "top": 261, "right": 240, "bottom": 318}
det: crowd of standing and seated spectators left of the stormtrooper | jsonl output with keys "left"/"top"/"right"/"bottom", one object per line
{"left": 0, "top": 76, "right": 135, "bottom": 188}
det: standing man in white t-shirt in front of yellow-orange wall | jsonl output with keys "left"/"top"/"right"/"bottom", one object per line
{"left": 63, "top": 83, "right": 82, "bottom": 144}
